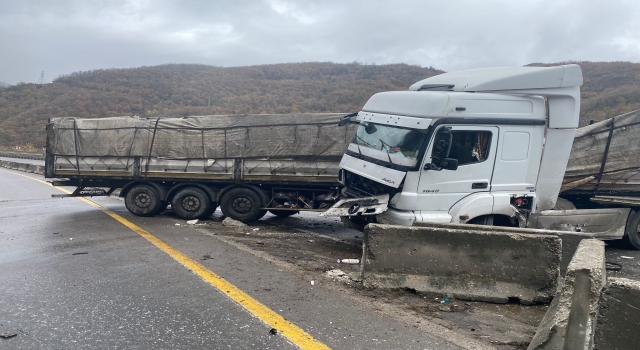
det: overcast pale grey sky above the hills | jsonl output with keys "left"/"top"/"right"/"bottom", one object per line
{"left": 0, "top": 0, "right": 640, "bottom": 84}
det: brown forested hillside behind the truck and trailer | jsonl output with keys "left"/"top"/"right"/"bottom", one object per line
{"left": 0, "top": 62, "right": 640, "bottom": 147}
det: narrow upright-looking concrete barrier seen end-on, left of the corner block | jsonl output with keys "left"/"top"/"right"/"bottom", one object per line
{"left": 528, "top": 239, "right": 606, "bottom": 350}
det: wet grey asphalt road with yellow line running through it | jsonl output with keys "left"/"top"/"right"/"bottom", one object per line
{"left": 0, "top": 169, "right": 458, "bottom": 349}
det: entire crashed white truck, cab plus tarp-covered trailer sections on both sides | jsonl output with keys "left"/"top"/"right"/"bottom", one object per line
{"left": 45, "top": 64, "right": 640, "bottom": 249}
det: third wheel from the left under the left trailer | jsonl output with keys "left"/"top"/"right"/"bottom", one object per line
{"left": 220, "top": 187, "right": 267, "bottom": 223}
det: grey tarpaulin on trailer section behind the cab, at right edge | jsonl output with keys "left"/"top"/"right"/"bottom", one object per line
{"left": 563, "top": 110, "right": 640, "bottom": 191}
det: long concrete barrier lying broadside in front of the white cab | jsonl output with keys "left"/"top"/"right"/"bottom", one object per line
{"left": 362, "top": 224, "right": 562, "bottom": 304}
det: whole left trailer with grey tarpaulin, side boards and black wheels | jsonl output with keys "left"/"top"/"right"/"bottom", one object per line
{"left": 45, "top": 113, "right": 355, "bottom": 222}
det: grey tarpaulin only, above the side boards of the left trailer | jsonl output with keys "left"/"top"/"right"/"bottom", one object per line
{"left": 51, "top": 113, "right": 354, "bottom": 158}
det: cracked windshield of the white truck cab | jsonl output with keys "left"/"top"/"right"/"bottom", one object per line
{"left": 351, "top": 122, "right": 427, "bottom": 166}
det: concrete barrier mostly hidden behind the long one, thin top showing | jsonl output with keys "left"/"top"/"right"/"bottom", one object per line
{"left": 415, "top": 222, "right": 594, "bottom": 276}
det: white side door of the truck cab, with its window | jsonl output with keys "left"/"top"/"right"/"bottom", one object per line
{"left": 416, "top": 125, "right": 498, "bottom": 214}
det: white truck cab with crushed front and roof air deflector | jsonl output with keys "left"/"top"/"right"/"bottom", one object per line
{"left": 321, "top": 65, "right": 582, "bottom": 227}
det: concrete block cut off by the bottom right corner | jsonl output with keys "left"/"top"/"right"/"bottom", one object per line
{"left": 594, "top": 278, "right": 640, "bottom": 350}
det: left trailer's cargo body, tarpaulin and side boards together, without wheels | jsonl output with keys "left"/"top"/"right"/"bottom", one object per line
{"left": 47, "top": 113, "right": 356, "bottom": 181}
